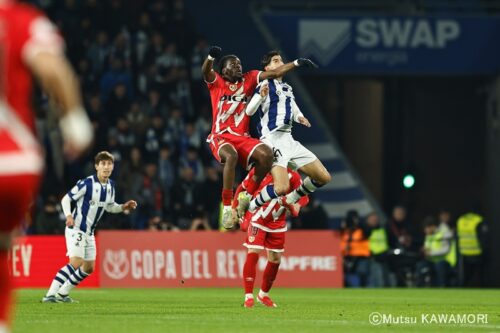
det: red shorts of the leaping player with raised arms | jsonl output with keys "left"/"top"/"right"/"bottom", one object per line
{"left": 210, "top": 132, "right": 264, "bottom": 168}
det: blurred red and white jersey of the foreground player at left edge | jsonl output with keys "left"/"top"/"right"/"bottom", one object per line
{"left": 0, "top": 0, "right": 63, "bottom": 175}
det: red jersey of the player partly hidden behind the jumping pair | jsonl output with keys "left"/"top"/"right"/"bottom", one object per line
{"left": 242, "top": 169, "right": 309, "bottom": 232}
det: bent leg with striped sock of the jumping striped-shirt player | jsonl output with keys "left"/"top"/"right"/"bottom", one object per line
{"left": 281, "top": 159, "right": 332, "bottom": 210}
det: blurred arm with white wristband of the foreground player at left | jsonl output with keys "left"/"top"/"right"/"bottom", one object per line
{"left": 28, "top": 52, "right": 94, "bottom": 157}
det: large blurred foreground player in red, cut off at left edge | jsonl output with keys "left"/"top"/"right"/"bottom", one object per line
{"left": 0, "top": 0, "right": 93, "bottom": 333}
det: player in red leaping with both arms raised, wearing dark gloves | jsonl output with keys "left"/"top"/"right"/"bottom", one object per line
{"left": 202, "top": 46, "right": 314, "bottom": 229}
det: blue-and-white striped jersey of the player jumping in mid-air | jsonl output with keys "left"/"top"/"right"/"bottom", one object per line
{"left": 247, "top": 79, "right": 303, "bottom": 138}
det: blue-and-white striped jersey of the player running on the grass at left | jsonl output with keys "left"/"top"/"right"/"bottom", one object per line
{"left": 67, "top": 175, "right": 118, "bottom": 235}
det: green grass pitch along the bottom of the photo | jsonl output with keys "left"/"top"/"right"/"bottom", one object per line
{"left": 13, "top": 288, "right": 500, "bottom": 333}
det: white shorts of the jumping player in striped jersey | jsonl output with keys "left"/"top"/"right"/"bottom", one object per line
{"left": 261, "top": 131, "right": 318, "bottom": 170}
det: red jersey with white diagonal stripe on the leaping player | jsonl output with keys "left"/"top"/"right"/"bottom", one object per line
{"left": 207, "top": 70, "right": 260, "bottom": 135}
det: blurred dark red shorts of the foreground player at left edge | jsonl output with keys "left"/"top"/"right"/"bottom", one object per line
{"left": 0, "top": 175, "right": 40, "bottom": 232}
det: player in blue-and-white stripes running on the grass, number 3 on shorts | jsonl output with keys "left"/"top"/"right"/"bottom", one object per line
{"left": 42, "top": 151, "right": 137, "bottom": 303}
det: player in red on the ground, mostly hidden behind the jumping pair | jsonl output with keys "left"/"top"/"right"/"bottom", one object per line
{"left": 233, "top": 169, "right": 309, "bottom": 308}
